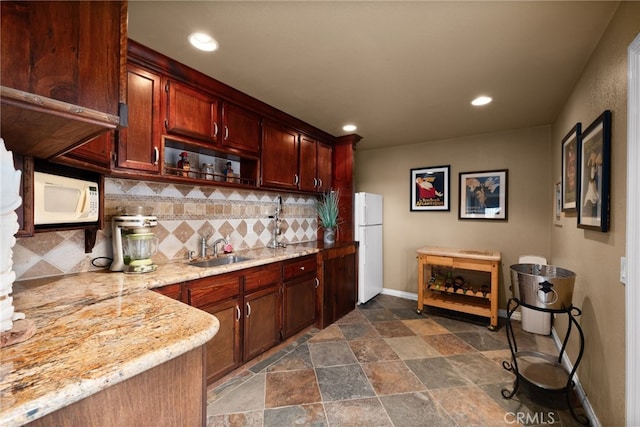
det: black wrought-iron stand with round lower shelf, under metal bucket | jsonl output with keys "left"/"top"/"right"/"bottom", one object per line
{"left": 501, "top": 298, "right": 589, "bottom": 425}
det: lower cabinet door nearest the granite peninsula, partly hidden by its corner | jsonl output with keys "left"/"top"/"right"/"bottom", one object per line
{"left": 202, "top": 299, "right": 242, "bottom": 384}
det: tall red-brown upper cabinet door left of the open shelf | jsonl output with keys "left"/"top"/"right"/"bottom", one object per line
{"left": 116, "top": 65, "right": 161, "bottom": 173}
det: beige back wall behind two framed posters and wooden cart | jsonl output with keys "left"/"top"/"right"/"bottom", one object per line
{"left": 355, "top": 126, "right": 553, "bottom": 307}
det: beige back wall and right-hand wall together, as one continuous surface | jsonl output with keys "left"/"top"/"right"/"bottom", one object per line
{"left": 356, "top": 2, "right": 640, "bottom": 426}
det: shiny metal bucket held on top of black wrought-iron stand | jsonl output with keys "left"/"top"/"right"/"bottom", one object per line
{"left": 510, "top": 264, "right": 576, "bottom": 310}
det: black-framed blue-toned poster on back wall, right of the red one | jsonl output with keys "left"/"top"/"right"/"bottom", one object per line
{"left": 458, "top": 169, "right": 509, "bottom": 220}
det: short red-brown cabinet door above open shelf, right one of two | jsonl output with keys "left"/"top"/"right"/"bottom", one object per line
{"left": 222, "top": 103, "right": 260, "bottom": 154}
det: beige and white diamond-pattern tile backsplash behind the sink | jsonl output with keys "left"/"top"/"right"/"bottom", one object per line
{"left": 13, "top": 178, "right": 318, "bottom": 280}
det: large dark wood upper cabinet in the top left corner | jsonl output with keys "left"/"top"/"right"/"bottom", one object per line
{"left": 0, "top": 1, "right": 127, "bottom": 158}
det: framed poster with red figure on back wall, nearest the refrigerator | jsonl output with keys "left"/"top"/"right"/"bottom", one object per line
{"left": 410, "top": 166, "right": 451, "bottom": 211}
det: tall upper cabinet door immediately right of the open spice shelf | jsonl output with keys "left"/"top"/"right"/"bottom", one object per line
{"left": 261, "top": 123, "right": 300, "bottom": 190}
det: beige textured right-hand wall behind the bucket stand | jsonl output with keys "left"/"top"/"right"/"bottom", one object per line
{"left": 551, "top": 2, "right": 640, "bottom": 426}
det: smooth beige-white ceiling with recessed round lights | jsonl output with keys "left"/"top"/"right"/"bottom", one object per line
{"left": 129, "top": 0, "right": 618, "bottom": 150}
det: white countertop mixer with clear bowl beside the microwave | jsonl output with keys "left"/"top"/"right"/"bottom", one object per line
{"left": 111, "top": 206, "right": 158, "bottom": 273}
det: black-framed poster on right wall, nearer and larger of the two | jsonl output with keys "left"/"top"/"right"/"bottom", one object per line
{"left": 577, "top": 110, "right": 611, "bottom": 233}
